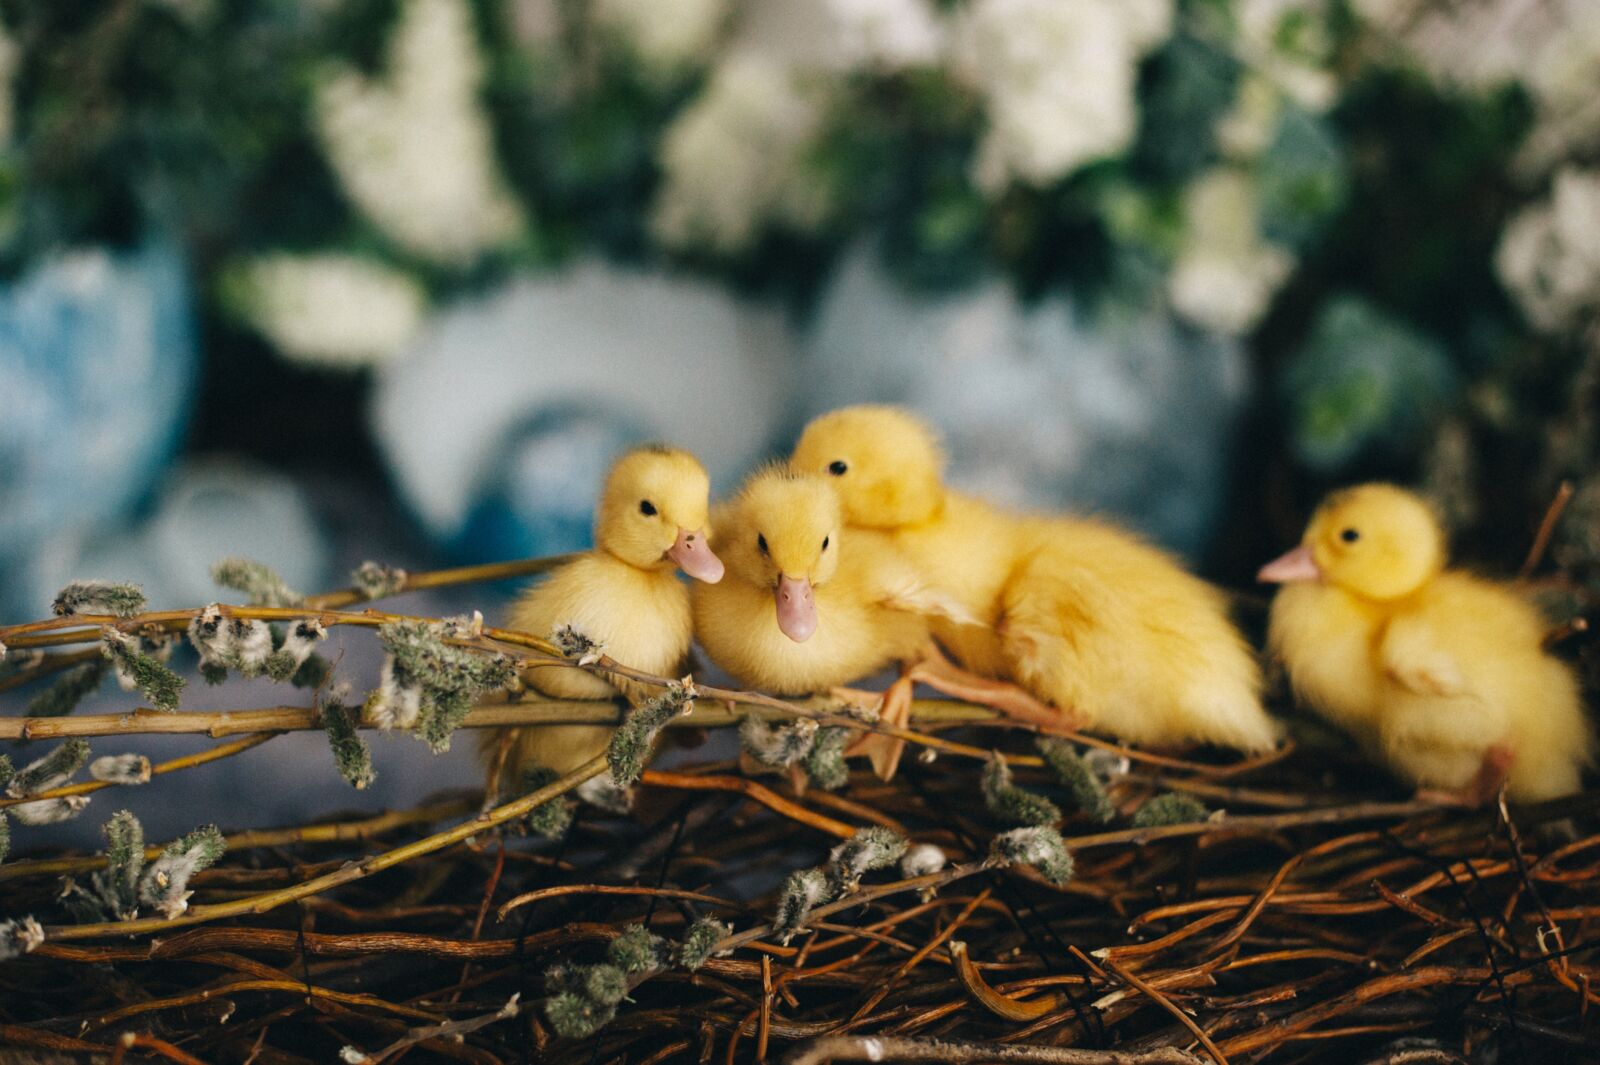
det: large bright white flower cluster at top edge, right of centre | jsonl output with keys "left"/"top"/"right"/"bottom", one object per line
{"left": 954, "top": 0, "right": 1171, "bottom": 190}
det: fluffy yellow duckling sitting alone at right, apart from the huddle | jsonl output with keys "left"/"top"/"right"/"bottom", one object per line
{"left": 1261, "top": 485, "right": 1594, "bottom": 804}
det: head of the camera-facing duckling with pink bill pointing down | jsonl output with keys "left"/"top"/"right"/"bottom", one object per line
{"left": 717, "top": 467, "right": 842, "bottom": 643}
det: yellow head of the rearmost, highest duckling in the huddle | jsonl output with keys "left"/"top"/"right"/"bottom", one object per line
{"left": 790, "top": 406, "right": 944, "bottom": 529}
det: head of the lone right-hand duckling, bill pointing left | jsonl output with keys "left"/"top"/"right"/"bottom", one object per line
{"left": 1259, "top": 485, "right": 1445, "bottom": 600}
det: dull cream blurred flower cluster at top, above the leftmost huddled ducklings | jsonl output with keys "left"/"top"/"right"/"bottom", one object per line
{"left": 651, "top": 53, "right": 827, "bottom": 253}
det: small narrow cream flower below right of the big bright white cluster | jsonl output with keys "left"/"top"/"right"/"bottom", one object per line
{"left": 1168, "top": 166, "right": 1294, "bottom": 336}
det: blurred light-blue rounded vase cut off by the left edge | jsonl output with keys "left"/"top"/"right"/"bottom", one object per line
{"left": 0, "top": 246, "right": 197, "bottom": 617}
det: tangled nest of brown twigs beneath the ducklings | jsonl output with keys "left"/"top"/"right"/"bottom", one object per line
{"left": 0, "top": 550, "right": 1600, "bottom": 1065}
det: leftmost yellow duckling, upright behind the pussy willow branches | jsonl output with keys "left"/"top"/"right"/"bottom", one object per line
{"left": 492, "top": 446, "right": 723, "bottom": 772}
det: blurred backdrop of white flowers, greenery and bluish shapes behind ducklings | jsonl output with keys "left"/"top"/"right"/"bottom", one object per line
{"left": 0, "top": 0, "right": 1600, "bottom": 832}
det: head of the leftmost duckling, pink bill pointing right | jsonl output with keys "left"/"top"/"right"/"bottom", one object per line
{"left": 595, "top": 445, "right": 722, "bottom": 584}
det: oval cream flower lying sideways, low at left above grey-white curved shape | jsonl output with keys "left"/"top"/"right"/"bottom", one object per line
{"left": 230, "top": 253, "right": 426, "bottom": 368}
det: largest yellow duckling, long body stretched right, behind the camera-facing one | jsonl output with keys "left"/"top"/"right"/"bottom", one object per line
{"left": 792, "top": 406, "right": 1278, "bottom": 750}
